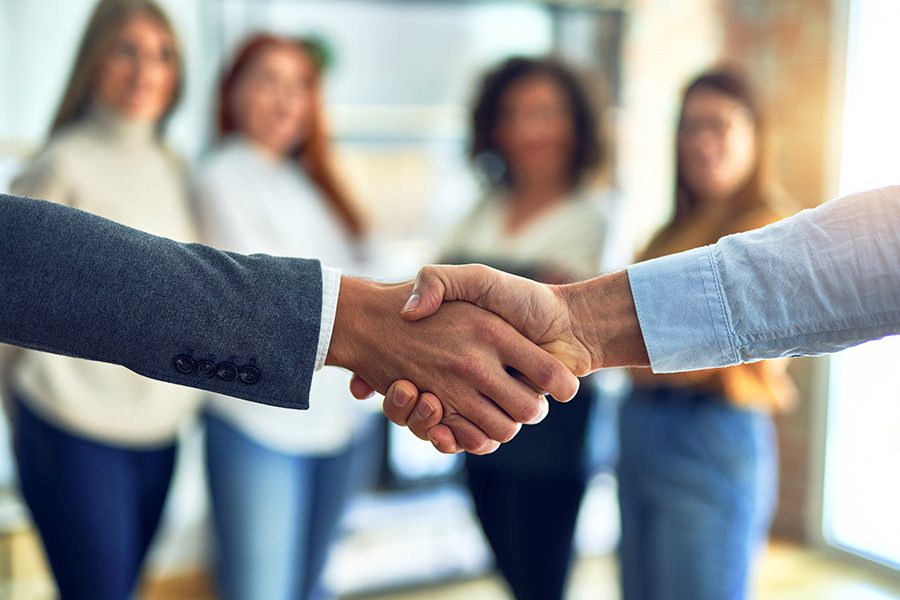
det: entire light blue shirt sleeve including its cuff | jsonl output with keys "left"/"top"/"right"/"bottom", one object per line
{"left": 628, "top": 186, "right": 900, "bottom": 373}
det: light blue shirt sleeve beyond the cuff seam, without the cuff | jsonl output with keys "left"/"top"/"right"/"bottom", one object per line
{"left": 712, "top": 187, "right": 900, "bottom": 362}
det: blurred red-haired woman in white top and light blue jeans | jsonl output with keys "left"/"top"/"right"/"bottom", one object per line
{"left": 195, "top": 35, "right": 371, "bottom": 600}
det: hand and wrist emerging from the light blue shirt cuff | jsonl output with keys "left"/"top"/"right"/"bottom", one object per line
{"left": 354, "top": 265, "right": 649, "bottom": 452}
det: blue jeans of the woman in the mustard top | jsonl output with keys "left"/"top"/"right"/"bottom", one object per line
{"left": 618, "top": 389, "right": 778, "bottom": 600}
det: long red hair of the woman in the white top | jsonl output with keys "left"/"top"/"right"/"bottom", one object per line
{"left": 218, "top": 34, "right": 363, "bottom": 236}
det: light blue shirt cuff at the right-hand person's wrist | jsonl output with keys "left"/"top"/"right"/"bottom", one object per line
{"left": 628, "top": 246, "right": 740, "bottom": 373}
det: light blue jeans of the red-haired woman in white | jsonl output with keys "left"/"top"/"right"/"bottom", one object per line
{"left": 205, "top": 414, "right": 365, "bottom": 600}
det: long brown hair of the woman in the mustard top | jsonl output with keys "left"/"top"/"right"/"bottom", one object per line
{"left": 645, "top": 68, "right": 776, "bottom": 258}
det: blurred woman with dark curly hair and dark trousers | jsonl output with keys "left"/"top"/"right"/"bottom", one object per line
{"left": 444, "top": 58, "right": 606, "bottom": 600}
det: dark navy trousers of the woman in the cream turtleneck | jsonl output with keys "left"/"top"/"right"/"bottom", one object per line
{"left": 13, "top": 394, "right": 175, "bottom": 600}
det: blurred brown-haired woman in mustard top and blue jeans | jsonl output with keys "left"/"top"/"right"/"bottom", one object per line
{"left": 619, "top": 71, "right": 794, "bottom": 600}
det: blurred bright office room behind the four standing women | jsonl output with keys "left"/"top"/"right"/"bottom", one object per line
{"left": 0, "top": 0, "right": 900, "bottom": 600}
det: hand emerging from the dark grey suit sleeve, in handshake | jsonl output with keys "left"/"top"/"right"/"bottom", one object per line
{"left": 325, "top": 277, "right": 578, "bottom": 453}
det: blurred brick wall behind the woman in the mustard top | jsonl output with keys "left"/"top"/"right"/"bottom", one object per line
{"left": 722, "top": 0, "right": 834, "bottom": 540}
